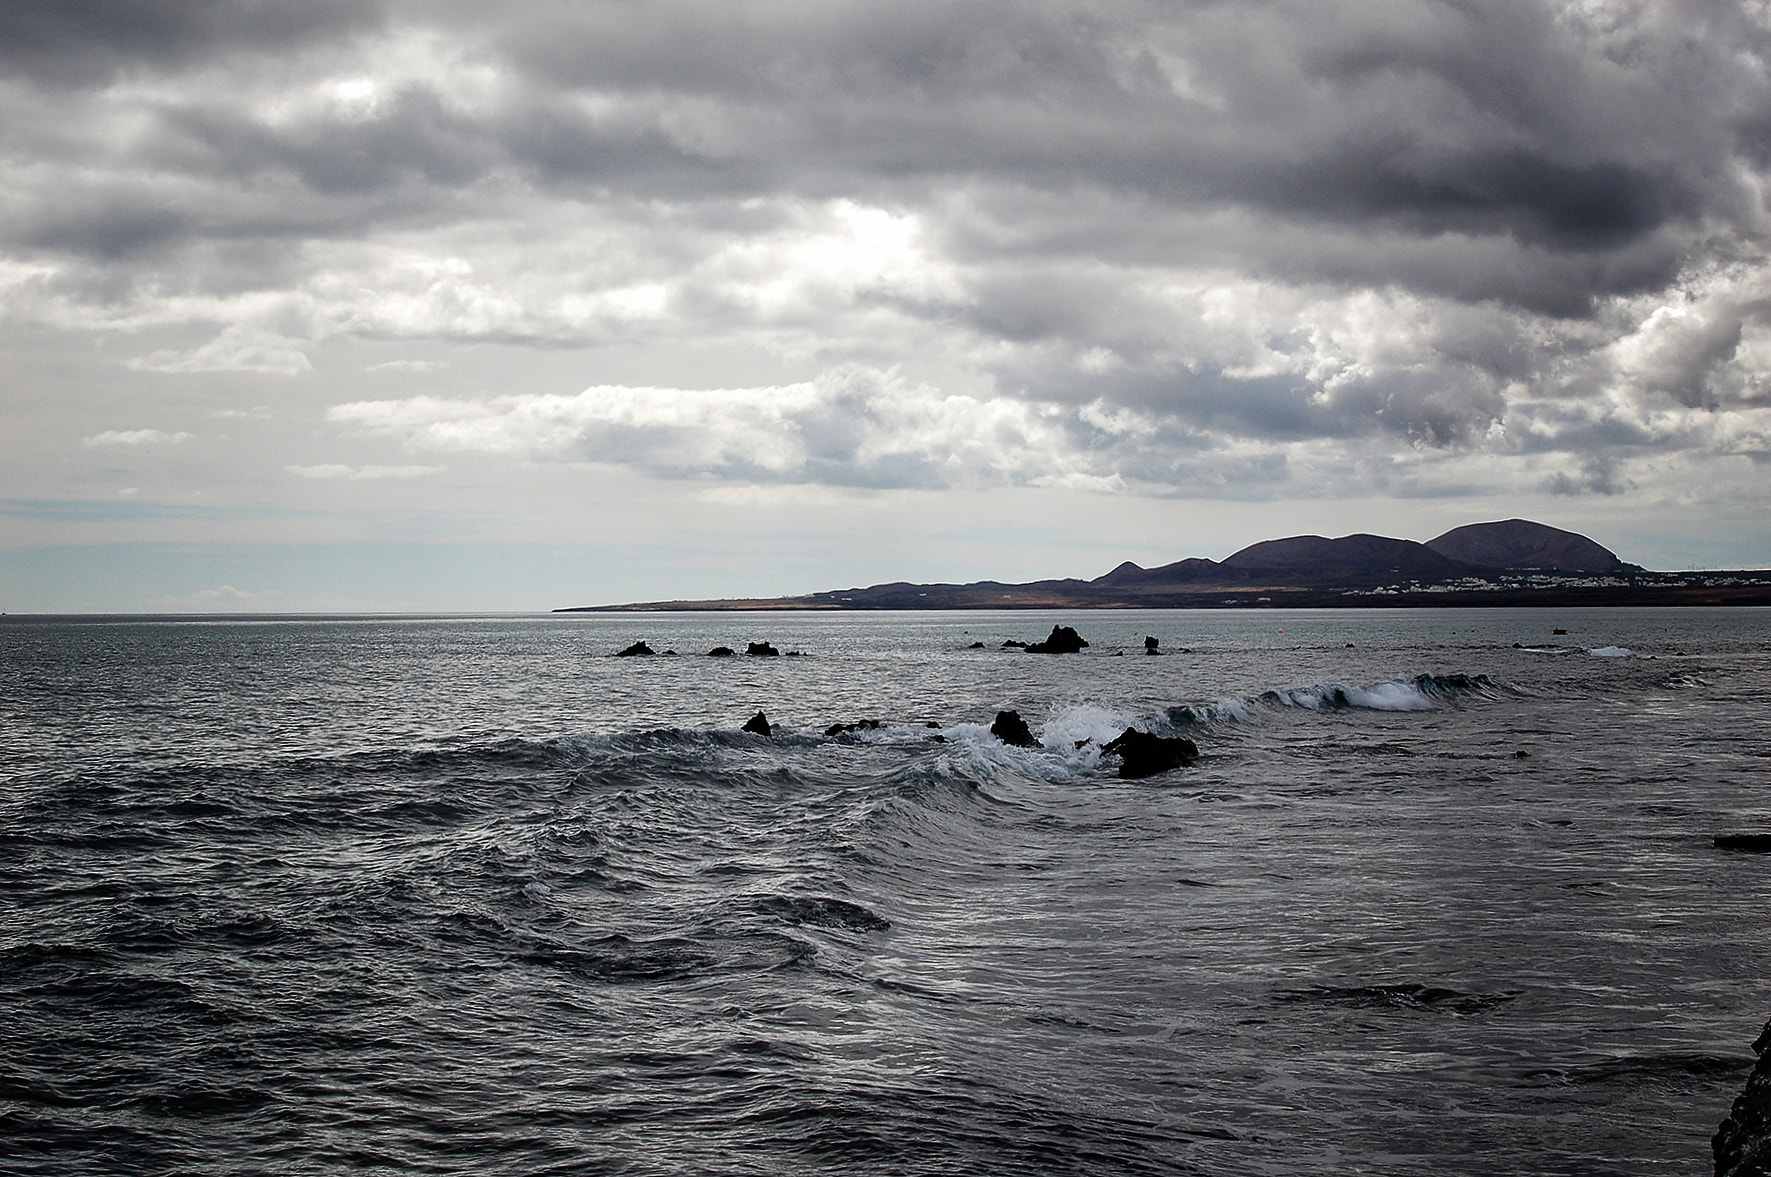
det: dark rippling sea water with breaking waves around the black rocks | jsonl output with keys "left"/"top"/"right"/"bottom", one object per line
{"left": 0, "top": 609, "right": 1771, "bottom": 1175}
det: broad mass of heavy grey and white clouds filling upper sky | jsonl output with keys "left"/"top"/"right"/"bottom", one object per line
{"left": 10, "top": 0, "right": 1771, "bottom": 513}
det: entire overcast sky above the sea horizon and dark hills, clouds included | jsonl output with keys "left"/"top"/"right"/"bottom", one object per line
{"left": 0, "top": 0, "right": 1771, "bottom": 612}
